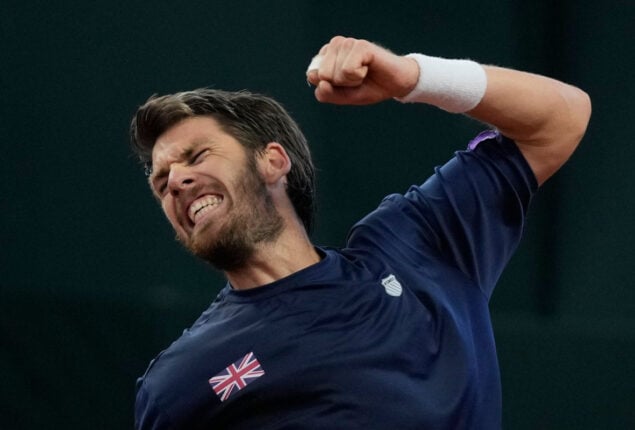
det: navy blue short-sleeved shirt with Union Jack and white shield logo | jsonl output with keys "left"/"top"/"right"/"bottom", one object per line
{"left": 136, "top": 132, "right": 537, "bottom": 430}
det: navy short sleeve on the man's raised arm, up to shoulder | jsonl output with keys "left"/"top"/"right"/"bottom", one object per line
{"left": 348, "top": 131, "right": 537, "bottom": 298}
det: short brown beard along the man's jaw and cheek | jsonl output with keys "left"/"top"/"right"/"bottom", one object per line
{"left": 179, "top": 163, "right": 284, "bottom": 272}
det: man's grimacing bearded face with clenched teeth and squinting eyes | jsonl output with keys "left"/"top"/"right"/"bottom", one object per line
{"left": 150, "top": 117, "right": 283, "bottom": 271}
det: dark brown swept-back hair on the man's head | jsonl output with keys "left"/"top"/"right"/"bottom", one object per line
{"left": 130, "top": 88, "right": 315, "bottom": 232}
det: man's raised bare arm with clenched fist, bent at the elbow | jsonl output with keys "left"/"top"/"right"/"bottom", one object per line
{"left": 307, "top": 36, "right": 591, "bottom": 184}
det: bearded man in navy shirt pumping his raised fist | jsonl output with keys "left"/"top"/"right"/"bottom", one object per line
{"left": 131, "top": 37, "right": 590, "bottom": 430}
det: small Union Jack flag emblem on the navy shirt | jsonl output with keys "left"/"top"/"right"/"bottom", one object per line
{"left": 209, "top": 352, "right": 265, "bottom": 402}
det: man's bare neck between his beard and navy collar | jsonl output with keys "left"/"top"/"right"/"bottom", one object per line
{"left": 225, "top": 226, "right": 320, "bottom": 290}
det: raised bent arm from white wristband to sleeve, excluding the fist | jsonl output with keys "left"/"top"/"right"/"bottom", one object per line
{"left": 400, "top": 54, "right": 591, "bottom": 184}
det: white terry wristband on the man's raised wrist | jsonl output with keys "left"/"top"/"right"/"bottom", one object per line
{"left": 397, "top": 54, "right": 487, "bottom": 113}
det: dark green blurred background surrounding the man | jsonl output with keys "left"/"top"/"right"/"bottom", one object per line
{"left": 0, "top": 0, "right": 635, "bottom": 430}
